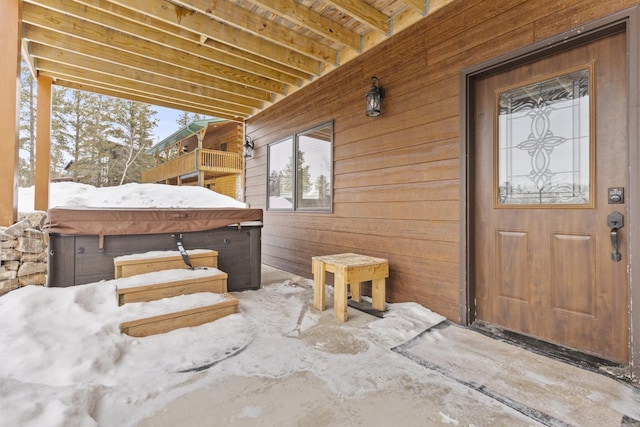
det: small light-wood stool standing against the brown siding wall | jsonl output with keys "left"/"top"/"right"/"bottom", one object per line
{"left": 311, "top": 253, "right": 389, "bottom": 322}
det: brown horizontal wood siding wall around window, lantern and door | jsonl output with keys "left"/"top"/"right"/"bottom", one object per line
{"left": 246, "top": 0, "right": 638, "bottom": 321}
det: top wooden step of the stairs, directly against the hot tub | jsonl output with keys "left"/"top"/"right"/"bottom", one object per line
{"left": 113, "top": 249, "right": 218, "bottom": 279}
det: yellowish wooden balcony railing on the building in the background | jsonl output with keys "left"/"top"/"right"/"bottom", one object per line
{"left": 142, "top": 149, "right": 242, "bottom": 182}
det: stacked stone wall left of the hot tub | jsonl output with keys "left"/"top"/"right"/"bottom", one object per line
{"left": 0, "top": 211, "right": 49, "bottom": 295}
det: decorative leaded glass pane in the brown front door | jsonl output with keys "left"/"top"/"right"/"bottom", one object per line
{"left": 497, "top": 69, "right": 591, "bottom": 205}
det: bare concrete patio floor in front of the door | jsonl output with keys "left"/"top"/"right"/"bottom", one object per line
{"left": 138, "top": 266, "right": 640, "bottom": 427}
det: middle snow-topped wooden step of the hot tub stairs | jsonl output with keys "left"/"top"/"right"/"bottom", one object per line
{"left": 116, "top": 267, "right": 228, "bottom": 305}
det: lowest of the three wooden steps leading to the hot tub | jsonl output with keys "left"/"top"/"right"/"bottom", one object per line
{"left": 120, "top": 293, "right": 238, "bottom": 337}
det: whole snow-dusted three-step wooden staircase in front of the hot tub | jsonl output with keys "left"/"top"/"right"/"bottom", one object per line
{"left": 114, "top": 250, "right": 238, "bottom": 337}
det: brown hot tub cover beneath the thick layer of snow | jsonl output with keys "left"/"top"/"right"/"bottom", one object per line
{"left": 45, "top": 207, "right": 262, "bottom": 247}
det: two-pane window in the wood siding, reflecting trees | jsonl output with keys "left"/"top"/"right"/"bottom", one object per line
{"left": 267, "top": 122, "right": 333, "bottom": 212}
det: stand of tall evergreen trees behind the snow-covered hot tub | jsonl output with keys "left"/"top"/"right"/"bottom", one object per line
{"left": 19, "top": 66, "right": 162, "bottom": 187}
